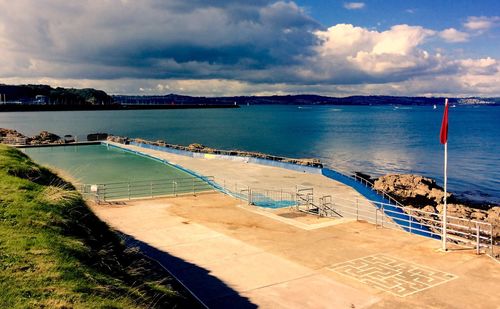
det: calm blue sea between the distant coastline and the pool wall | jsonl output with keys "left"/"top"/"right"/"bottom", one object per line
{"left": 0, "top": 106, "right": 500, "bottom": 203}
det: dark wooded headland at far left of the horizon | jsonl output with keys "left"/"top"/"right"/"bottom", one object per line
{"left": 0, "top": 84, "right": 113, "bottom": 106}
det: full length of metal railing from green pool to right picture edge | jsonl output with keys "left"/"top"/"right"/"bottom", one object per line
{"left": 80, "top": 176, "right": 498, "bottom": 256}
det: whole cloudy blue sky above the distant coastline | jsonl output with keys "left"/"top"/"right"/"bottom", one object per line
{"left": 0, "top": 0, "right": 500, "bottom": 97}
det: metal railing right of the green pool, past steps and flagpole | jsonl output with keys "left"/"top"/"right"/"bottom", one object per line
{"left": 218, "top": 177, "right": 498, "bottom": 255}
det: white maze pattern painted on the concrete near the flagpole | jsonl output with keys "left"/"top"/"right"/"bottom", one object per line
{"left": 328, "top": 254, "right": 457, "bottom": 297}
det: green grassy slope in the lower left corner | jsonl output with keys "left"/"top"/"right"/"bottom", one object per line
{"left": 0, "top": 145, "right": 199, "bottom": 308}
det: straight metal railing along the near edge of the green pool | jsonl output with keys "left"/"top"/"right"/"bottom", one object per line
{"left": 80, "top": 177, "right": 216, "bottom": 203}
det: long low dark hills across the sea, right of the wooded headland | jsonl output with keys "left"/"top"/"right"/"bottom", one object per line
{"left": 113, "top": 94, "right": 500, "bottom": 105}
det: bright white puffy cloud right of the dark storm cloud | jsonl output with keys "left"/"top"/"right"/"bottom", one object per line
{"left": 307, "top": 24, "right": 441, "bottom": 84}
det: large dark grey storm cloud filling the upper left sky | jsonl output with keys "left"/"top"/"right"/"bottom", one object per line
{"left": 0, "top": 0, "right": 319, "bottom": 78}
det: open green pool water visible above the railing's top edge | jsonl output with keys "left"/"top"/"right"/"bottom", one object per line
{"left": 23, "top": 145, "right": 194, "bottom": 184}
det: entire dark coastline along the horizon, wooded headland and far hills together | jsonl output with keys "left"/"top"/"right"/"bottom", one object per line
{"left": 0, "top": 84, "right": 500, "bottom": 112}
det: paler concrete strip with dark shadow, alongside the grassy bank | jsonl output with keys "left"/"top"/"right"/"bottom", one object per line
{"left": 93, "top": 194, "right": 378, "bottom": 308}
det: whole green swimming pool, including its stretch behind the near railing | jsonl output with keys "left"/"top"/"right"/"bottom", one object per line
{"left": 23, "top": 144, "right": 214, "bottom": 200}
